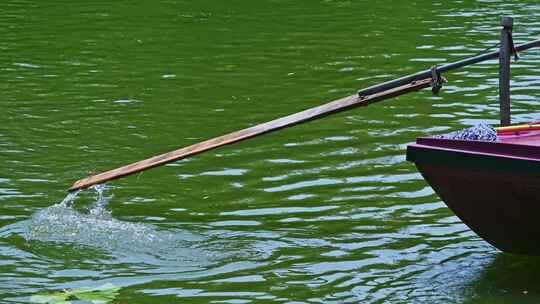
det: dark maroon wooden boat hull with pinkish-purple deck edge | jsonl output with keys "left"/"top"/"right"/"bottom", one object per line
{"left": 407, "top": 127, "right": 540, "bottom": 255}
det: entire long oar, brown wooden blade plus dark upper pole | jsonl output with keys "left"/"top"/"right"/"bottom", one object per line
{"left": 69, "top": 39, "right": 540, "bottom": 191}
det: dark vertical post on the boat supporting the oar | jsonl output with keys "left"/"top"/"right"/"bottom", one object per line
{"left": 499, "top": 16, "right": 514, "bottom": 126}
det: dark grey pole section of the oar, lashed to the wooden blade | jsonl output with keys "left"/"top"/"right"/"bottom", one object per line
{"left": 358, "top": 39, "right": 540, "bottom": 96}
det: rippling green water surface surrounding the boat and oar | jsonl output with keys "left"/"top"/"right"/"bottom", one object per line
{"left": 0, "top": 0, "right": 540, "bottom": 304}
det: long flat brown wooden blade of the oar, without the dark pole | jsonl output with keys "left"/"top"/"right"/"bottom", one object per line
{"left": 69, "top": 77, "right": 431, "bottom": 191}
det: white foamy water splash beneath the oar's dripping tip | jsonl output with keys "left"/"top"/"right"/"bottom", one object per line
{"left": 23, "top": 185, "right": 205, "bottom": 260}
